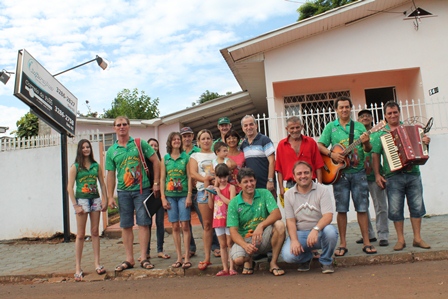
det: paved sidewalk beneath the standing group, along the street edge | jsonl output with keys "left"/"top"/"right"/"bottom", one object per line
{"left": 0, "top": 215, "right": 448, "bottom": 283}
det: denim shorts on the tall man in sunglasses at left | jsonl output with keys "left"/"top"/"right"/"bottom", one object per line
{"left": 117, "top": 188, "right": 151, "bottom": 228}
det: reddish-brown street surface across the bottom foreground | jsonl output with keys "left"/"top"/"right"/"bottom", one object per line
{"left": 0, "top": 260, "right": 448, "bottom": 299}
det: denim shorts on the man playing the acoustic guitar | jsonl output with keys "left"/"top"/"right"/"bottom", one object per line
{"left": 333, "top": 170, "right": 369, "bottom": 213}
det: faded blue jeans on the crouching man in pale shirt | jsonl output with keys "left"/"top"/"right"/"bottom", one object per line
{"left": 281, "top": 224, "right": 338, "bottom": 265}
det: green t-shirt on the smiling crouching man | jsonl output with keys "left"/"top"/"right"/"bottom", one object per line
{"left": 227, "top": 189, "right": 278, "bottom": 238}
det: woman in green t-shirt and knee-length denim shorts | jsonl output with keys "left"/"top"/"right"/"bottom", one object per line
{"left": 160, "top": 132, "right": 192, "bottom": 269}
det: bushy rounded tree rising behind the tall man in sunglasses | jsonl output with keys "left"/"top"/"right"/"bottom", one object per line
{"left": 103, "top": 88, "right": 160, "bottom": 119}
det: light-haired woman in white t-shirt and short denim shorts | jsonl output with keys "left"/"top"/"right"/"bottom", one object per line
{"left": 189, "top": 130, "right": 216, "bottom": 270}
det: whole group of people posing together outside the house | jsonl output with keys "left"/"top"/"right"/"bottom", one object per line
{"left": 68, "top": 97, "right": 430, "bottom": 280}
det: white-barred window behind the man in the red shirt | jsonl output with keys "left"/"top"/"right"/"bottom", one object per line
{"left": 283, "top": 90, "right": 350, "bottom": 137}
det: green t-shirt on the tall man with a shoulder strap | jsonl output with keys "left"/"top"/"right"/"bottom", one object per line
{"left": 106, "top": 137, "right": 155, "bottom": 191}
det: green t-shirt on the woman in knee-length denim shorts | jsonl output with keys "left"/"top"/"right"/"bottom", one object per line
{"left": 164, "top": 152, "right": 190, "bottom": 197}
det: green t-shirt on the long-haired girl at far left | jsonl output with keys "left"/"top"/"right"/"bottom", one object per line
{"left": 75, "top": 162, "right": 100, "bottom": 199}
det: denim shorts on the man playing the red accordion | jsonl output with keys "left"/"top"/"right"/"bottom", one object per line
{"left": 386, "top": 173, "right": 426, "bottom": 221}
